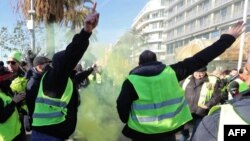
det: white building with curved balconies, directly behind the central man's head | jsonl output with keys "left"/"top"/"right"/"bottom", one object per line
{"left": 130, "top": 0, "right": 166, "bottom": 62}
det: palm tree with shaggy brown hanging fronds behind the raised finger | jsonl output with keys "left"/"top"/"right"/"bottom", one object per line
{"left": 12, "top": 0, "right": 92, "bottom": 57}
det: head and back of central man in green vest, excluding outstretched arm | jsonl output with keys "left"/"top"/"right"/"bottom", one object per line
{"left": 117, "top": 50, "right": 191, "bottom": 141}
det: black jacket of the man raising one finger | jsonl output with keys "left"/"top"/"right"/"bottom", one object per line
{"left": 33, "top": 30, "right": 91, "bottom": 139}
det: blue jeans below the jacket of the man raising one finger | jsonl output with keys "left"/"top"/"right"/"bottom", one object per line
{"left": 31, "top": 130, "right": 63, "bottom": 141}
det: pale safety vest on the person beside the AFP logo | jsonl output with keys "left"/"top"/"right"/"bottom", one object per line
{"left": 209, "top": 104, "right": 248, "bottom": 141}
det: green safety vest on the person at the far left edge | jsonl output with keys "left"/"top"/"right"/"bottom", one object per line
{"left": 0, "top": 92, "right": 21, "bottom": 141}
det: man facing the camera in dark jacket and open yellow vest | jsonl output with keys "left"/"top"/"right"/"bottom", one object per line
{"left": 180, "top": 67, "right": 221, "bottom": 141}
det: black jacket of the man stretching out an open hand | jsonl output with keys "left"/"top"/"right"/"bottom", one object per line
{"left": 117, "top": 34, "right": 235, "bottom": 140}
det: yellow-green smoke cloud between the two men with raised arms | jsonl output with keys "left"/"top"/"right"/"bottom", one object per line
{"left": 70, "top": 30, "right": 136, "bottom": 141}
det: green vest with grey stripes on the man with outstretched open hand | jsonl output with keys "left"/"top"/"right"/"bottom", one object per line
{"left": 128, "top": 67, "right": 192, "bottom": 134}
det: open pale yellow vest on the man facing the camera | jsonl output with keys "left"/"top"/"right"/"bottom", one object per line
{"left": 182, "top": 76, "right": 218, "bottom": 106}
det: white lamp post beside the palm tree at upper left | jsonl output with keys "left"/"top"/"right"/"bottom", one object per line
{"left": 27, "top": 0, "right": 36, "bottom": 52}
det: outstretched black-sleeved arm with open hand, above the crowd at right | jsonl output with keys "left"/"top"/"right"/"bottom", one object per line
{"left": 171, "top": 21, "right": 245, "bottom": 81}
